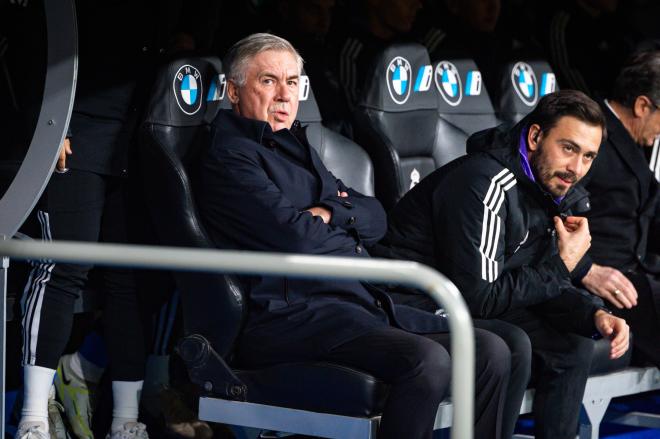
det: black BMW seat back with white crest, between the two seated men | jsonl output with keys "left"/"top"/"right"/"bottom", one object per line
{"left": 353, "top": 44, "right": 440, "bottom": 210}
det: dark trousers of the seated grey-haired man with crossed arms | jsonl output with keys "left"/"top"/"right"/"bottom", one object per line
{"left": 239, "top": 326, "right": 520, "bottom": 439}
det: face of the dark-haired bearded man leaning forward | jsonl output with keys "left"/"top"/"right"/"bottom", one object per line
{"left": 527, "top": 116, "right": 603, "bottom": 198}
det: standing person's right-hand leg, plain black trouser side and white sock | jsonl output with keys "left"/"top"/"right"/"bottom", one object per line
{"left": 101, "top": 177, "right": 146, "bottom": 437}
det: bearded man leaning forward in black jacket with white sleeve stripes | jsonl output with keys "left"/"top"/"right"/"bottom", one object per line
{"left": 376, "top": 90, "right": 628, "bottom": 439}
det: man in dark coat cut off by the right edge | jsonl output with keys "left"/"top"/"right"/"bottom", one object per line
{"left": 582, "top": 51, "right": 660, "bottom": 366}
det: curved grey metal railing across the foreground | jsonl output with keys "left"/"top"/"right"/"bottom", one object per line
{"left": 0, "top": 240, "right": 474, "bottom": 439}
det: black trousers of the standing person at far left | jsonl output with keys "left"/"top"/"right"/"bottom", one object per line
{"left": 22, "top": 169, "right": 145, "bottom": 381}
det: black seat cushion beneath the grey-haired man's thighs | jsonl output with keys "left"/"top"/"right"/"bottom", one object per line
{"left": 235, "top": 362, "right": 389, "bottom": 417}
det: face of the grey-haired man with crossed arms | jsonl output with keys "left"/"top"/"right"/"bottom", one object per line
{"left": 227, "top": 50, "right": 300, "bottom": 131}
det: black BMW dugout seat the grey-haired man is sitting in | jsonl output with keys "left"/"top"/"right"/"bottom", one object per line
{"left": 140, "top": 58, "right": 388, "bottom": 438}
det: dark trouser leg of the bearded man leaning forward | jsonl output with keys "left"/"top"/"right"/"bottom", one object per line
{"left": 501, "top": 309, "right": 594, "bottom": 439}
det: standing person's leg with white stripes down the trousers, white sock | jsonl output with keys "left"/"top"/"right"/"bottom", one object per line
{"left": 17, "top": 170, "right": 105, "bottom": 437}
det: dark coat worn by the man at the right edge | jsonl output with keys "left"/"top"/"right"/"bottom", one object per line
{"left": 586, "top": 103, "right": 660, "bottom": 273}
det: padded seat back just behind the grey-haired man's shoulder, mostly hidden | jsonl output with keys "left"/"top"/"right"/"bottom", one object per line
{"left": 297, "top": 75, "right": 375, "bottom": 197}
